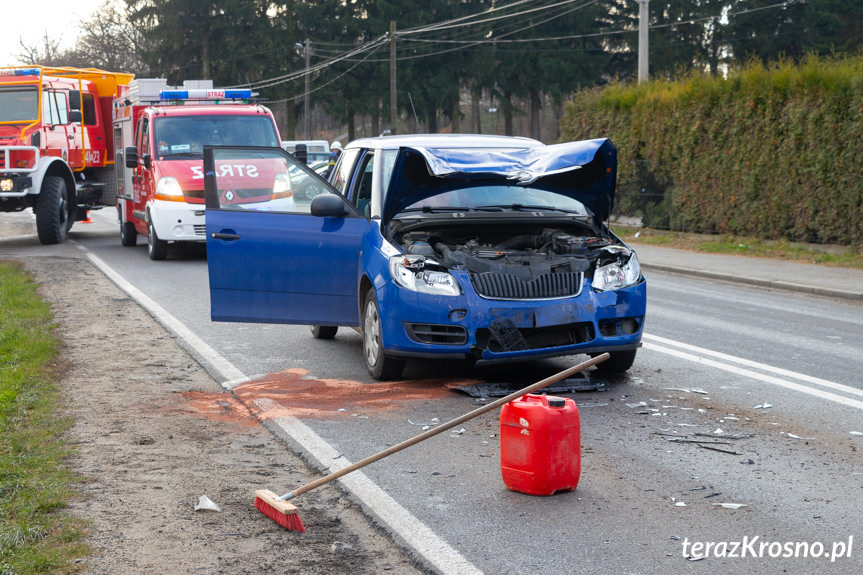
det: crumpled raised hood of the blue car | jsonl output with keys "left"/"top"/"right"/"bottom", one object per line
{"left": 382, "top": 138, "right": 617, "bottom": 222}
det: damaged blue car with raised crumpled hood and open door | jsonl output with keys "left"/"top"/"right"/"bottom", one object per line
{"left": 204, "top": 135, "right": 647, "bottom": 379}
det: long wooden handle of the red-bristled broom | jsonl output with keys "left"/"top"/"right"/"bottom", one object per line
{"left": 279, "top": 353, "right": 610, "bottom": 501}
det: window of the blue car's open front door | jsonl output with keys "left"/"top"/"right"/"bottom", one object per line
{"left": 204, "top": 147, "right": 344, "bottom": 214}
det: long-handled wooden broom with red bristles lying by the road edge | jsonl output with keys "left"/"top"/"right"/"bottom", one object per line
{"left": 255, "top": 353, "right": 609, "bottom": 532}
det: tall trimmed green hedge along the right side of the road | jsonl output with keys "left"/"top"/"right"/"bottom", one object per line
{"left": 561, "top": 57, "right": 863, "bottom": 247}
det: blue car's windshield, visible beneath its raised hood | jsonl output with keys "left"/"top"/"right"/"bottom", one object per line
{"left": 403, "top": 185, "right": 588, "bottom": 216}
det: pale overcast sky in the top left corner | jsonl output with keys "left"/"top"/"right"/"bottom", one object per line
{"left": 0, "top": 0, "right": 104, "bottom": 66}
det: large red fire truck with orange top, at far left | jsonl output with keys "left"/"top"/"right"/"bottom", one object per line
{"left": 0, "top": 66, "right": 133, "bottom": 244}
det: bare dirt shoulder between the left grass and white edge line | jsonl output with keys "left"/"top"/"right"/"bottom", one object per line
{"left": 0, "top": 226, "right": 423, "bottom": 575}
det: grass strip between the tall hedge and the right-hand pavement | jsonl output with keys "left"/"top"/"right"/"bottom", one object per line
{"left": 612, "top": 226, "right": 863, "bottom": 269}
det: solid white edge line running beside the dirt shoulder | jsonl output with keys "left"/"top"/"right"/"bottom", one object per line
{"left": 88, "top": 251, "right": 482, "bottom": 575}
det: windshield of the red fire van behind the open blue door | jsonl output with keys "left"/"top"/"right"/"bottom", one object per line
{"left": 154, "top": 114, "right": 279, "bottom": 159}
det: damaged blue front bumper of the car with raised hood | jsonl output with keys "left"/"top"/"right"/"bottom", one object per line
{"left": 379, "top": 272, "right": 647, "bottom": 363}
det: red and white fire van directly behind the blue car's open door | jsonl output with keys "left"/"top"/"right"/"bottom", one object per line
{"left": 114, "top": 79, "right": 280, "bottom": 260}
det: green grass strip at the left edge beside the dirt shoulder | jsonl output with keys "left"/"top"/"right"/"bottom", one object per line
{"left": 0, "top": 261, "right": 87, "bottom": 575}
